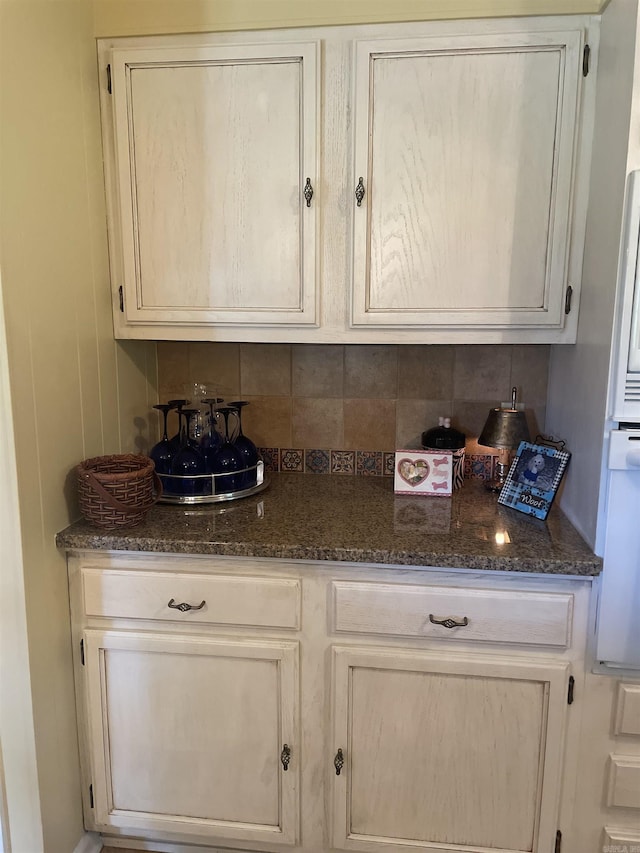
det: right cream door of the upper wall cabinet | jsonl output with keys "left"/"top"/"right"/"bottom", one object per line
{"left": 351, "top": 22, "right": 583, "bottom": 330}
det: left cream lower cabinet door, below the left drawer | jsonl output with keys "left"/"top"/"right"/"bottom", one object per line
{"left": 84, "top": 629, "right": 300, "bottom": 845}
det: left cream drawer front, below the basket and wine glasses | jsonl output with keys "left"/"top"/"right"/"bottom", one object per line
{"left": 82, "top": 568, "right": 300, "bottom": 630}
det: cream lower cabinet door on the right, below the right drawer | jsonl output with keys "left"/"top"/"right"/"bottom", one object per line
{"left": 328, "top": 647, "right": 568, "bottom": 853}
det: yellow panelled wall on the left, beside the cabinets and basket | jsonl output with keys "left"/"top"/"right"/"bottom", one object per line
{"left": 0, "top": 0, "right": 155, "bottom": 853}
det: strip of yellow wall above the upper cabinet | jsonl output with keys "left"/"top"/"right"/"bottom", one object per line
{"left": 94, "top": 0, "right": 607, "bottom": 36}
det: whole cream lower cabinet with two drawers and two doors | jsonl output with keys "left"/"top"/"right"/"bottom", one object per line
{"left": 69, "top": 552, "right": 590, "bottom": 853}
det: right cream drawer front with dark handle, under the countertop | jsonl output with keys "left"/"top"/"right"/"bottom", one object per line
{"left": 332, "top": 581, "right": 573, "bottom": 648}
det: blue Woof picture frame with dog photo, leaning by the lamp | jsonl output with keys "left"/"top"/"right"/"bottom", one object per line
{"left": 498, "top": 441, "right": 571, "bottom": 520}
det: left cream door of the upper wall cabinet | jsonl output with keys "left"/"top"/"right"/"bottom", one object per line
{"left": 103, "top": 39, "right": 319, "bottom": 327}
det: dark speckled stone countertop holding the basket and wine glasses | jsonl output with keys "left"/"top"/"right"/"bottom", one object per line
{"left": 56, "top": 474, "right": 601, "bottom": 576}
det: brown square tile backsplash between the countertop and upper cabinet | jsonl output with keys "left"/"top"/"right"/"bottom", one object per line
{"left": 157, "top": 342, "right": 550, "bottom": 466}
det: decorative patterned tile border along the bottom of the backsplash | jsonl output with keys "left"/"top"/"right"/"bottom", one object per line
{"left": 258, "top": 447, "right": 498, "bottom": 480}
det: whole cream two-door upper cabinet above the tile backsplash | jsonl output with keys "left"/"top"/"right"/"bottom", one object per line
{"left": 99, "top": 16, "right": 598, "bottom": 343}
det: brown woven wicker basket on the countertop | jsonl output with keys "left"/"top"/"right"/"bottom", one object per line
{"left": 76, "top": 454, "right": 162, "bottom": 529}
